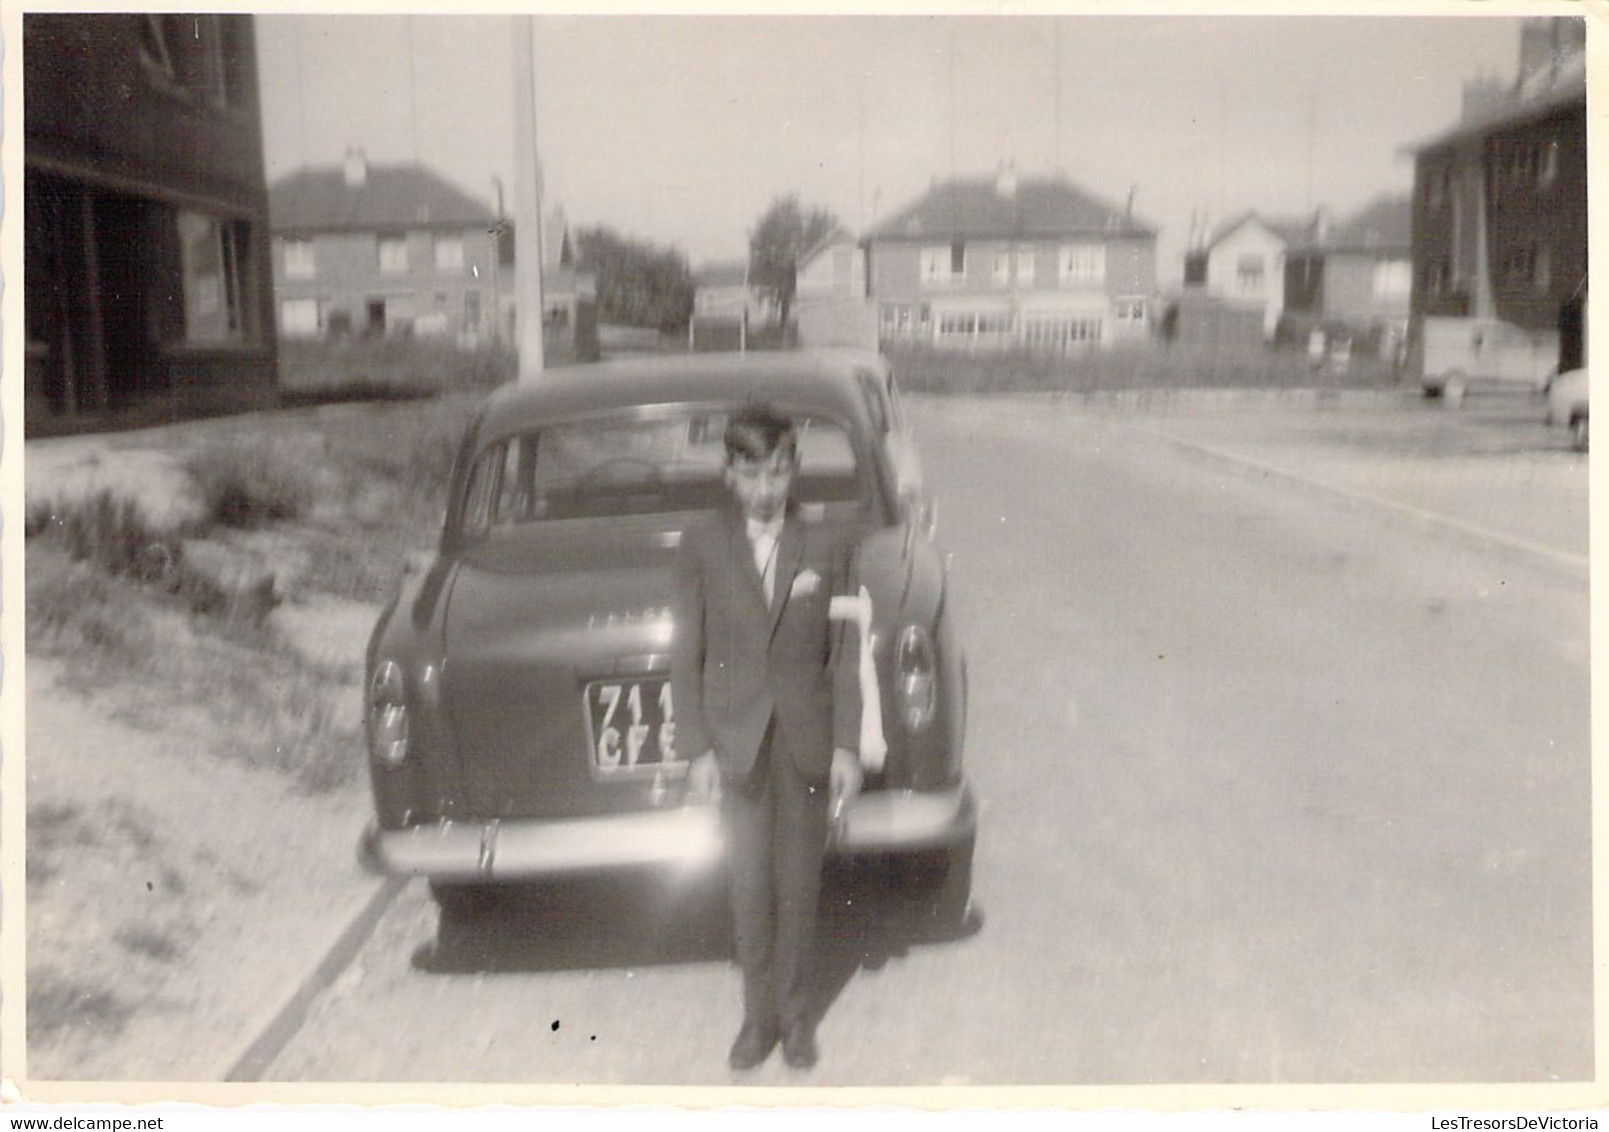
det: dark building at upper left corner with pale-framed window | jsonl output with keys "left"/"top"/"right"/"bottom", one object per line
{"left": 23, "top": 13, "right": 277, "bottom": 434}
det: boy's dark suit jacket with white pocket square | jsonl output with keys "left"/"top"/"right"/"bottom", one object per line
{"left": 671, "top": 503, "right": 861, "bottom": 781}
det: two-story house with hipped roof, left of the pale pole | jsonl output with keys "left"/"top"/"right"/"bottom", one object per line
{"left": 269, "top": 150, "right": 515, "bottom": 339}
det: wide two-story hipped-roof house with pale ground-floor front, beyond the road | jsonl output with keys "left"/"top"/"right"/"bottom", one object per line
{"left": 866, "top": 167, "right": 1157, "bottom": 351}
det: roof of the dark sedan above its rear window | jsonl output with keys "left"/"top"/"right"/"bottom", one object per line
{"left": 476, "top": 349, "right": 883, "bottom": 442}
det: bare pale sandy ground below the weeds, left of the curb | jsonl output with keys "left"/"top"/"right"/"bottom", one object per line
{"left": 27, "top": 659, "right": 377, "bottom": 1081}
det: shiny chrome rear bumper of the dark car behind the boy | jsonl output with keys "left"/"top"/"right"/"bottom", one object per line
{"left": 359, "top": 785, "right": 978, "bottom": 881}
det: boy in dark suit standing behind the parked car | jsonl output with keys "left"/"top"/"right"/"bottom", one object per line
{"left": 671, "top": 405, "right": 861, "bottom": 1069}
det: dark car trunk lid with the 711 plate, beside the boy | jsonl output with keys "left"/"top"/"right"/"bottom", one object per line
{"left": 444, "top": 516, "right": 685, "bottom": 817}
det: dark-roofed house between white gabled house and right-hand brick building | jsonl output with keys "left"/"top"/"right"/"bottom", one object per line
{"left": 1284, "top": 193, "right": 1413, "bottom": 341}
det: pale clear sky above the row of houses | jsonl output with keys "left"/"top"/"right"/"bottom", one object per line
{"left": 257, "top": 5, "right": 1559, "bottom": 281}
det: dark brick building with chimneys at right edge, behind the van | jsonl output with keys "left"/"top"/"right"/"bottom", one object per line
{"left": 1408, "top": 18, "right": 1586, "bottom": 368}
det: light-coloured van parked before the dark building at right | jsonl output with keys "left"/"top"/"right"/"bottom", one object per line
{"left": 1419, "top": 315, "right": 1559, "bottom": 405}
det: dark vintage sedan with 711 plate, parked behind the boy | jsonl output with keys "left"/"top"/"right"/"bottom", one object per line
{"left": 360, "top": 351, "right": 977, "bottom": 923}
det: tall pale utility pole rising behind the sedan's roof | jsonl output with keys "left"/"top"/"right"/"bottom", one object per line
{"left": 513, "top": 16, "right": 542, "bottom": 384}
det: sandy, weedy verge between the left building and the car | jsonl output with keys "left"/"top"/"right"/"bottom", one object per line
{"left": 26, "top": 399, "right": 471, "bottom": 1081}
